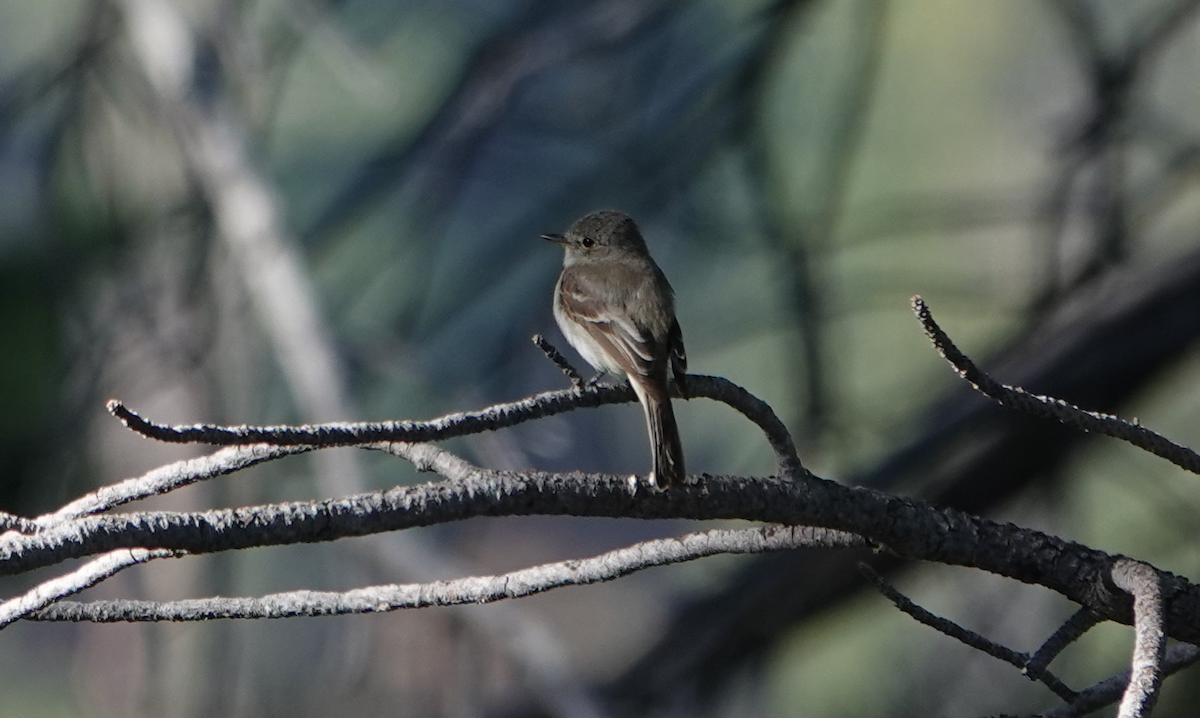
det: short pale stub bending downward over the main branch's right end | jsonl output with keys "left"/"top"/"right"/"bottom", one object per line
{"left": 1112, "top": 558, "right": 1166, "bottom": 718}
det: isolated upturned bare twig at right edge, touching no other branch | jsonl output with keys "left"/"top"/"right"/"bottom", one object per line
{"left": 912, "top": 297, "right": 1200, "bottom": 473}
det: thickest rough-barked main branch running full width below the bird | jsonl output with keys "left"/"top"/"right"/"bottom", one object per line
{"left": 0, "top": 469, "right": 1200, "bottom": 641}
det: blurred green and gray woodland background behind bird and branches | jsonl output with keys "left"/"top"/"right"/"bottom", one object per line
{"left": 0, "top": 0, "right": 1200, "bottom": 716}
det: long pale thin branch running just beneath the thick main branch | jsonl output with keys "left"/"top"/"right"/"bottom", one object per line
{"left": 29, "top": 526, "right": 869, "bottom": 622}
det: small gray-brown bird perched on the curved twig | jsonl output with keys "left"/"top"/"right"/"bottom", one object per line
{"left": 542, "top": 210, "right": 688, "bottom": 489}
